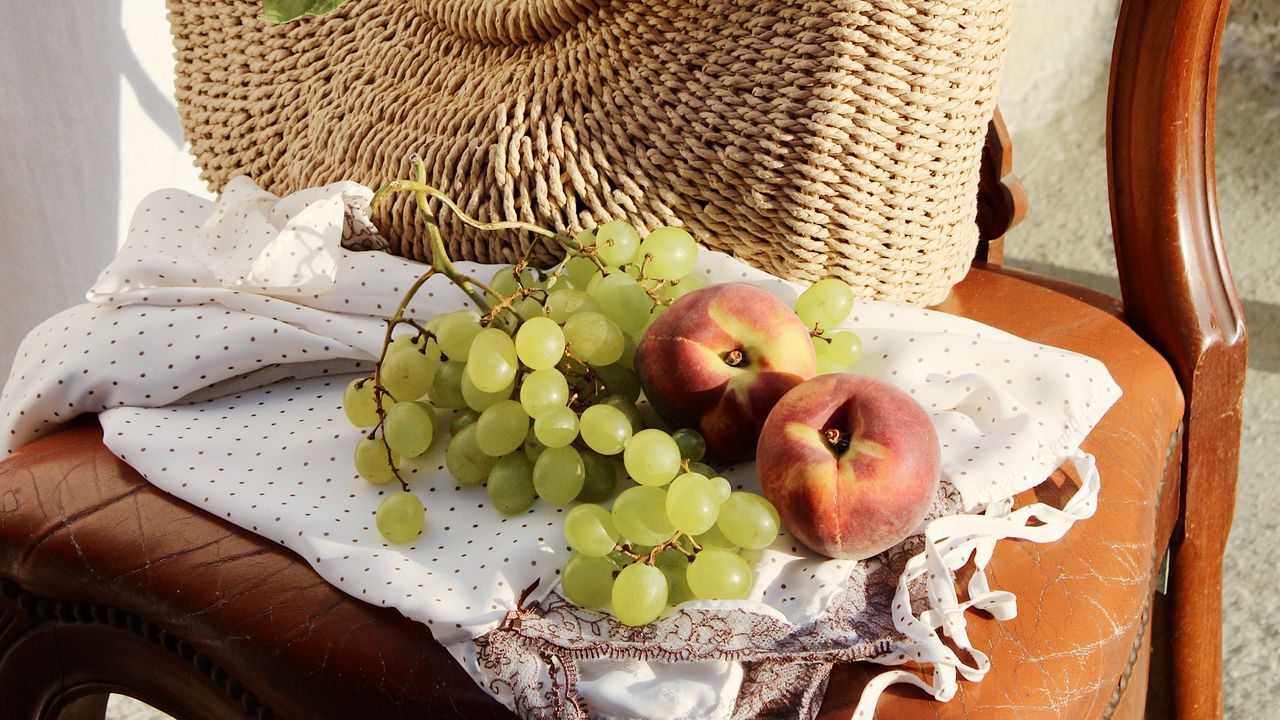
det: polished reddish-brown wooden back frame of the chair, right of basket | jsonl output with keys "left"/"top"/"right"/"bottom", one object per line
{"left": 975, "top": 0, "right": 1248, "bottom": 720}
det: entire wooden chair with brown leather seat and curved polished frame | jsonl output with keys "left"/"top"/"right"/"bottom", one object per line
{"left": 0, "top": 0, "right": 1245, "bottom": 720}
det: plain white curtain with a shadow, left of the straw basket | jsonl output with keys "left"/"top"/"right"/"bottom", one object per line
{"left": 0, "top": 0, "right": 207, "bottom": 379}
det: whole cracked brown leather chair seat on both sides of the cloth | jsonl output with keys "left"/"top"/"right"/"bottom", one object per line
{"left": 0, "top": 265, "right": 1184, "bottom": 719}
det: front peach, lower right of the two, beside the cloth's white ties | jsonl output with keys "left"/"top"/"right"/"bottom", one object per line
{"left": 755, "top": 373, "right": 942, "bottom": 560}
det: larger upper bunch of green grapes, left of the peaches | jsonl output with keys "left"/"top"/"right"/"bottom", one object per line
{"left": 343, "top": 215, "right": 705, "bottom": 543}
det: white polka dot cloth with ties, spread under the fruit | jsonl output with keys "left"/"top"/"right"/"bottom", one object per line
{"left": 0, "top": 178, "right": 1119, "bottom": 717}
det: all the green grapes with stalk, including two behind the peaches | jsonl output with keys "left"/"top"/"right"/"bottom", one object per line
{"left": 343, "top": 158, "right": 860, "bottom": 625}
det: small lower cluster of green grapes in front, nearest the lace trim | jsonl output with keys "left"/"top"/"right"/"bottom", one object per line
{"left": 561, "top": 428, "right": 781, "bottom": 626}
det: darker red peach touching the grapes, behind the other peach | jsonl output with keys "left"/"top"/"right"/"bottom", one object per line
{"left": 636, "top": 283, "right": 817, "bottom": 461}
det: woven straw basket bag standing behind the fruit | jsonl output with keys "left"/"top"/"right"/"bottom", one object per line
{"left": 169, "top": 0, "right": 1010, "bottom": 304}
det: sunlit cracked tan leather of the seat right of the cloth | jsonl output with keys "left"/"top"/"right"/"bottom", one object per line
{"left": 822, "top": 269, "right": 1183, "bottom": 720}
